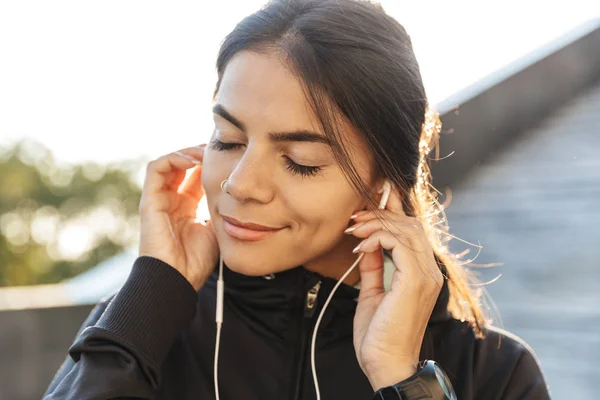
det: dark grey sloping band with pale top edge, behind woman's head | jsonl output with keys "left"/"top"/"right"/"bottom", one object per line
{"left": 431, "top": 19, "right": 600, "bottom": 189}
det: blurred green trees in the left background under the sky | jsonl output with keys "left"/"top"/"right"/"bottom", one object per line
{"left": 0, "top": 141, "right": 143, "bottom": 286}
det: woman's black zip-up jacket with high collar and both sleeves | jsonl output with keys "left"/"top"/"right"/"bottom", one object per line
{"left": 44, "top": 257, "right": 549, "bottom": 400}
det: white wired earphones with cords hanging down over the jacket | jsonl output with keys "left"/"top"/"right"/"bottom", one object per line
{"left": 214, "top": 179, "right": 392, "bottom": 400}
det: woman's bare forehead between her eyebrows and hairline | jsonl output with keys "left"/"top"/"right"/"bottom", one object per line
{"left": 215, "top": 50, "right": 320, "bottom": 132}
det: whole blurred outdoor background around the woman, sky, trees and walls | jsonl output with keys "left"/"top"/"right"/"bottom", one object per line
{"left": 0, "top": 0, "right": 600, "bottom": 400}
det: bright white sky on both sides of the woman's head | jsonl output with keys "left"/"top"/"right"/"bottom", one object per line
{"left": 0, "top": 0, "right": 600, "bottom": 162}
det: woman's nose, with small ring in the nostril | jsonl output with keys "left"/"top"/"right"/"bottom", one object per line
{"left": 227, "top": 145, "right": 274, "bottom": 204}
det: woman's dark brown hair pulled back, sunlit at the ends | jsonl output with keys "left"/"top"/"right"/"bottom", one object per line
{"left": 215, "top": 0, "right": 486, "bottom": 336}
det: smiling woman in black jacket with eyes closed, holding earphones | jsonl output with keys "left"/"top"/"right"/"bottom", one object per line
{"left": 45, "top": 0, "right": 549, "bottom": 400}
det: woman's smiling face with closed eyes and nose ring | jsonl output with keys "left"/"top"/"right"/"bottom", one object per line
{"left": 202, "top": 51, "right": 378, "bottom": 275}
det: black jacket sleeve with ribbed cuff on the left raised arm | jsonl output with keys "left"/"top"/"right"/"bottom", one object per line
{"left": 43, "top": 257, "right": 202, "bottom": 400}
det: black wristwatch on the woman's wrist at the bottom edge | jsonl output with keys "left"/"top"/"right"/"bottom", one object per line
{"left": 373, "top": 360, "right": 456, "bottom": 400}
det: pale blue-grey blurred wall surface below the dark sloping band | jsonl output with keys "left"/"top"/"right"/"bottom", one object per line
{"left": 446, "top": 83, "right": 600, "bottom": 399}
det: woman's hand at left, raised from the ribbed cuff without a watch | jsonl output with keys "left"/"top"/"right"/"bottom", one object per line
{"left": 139, "top": 145, "right": 219, "bottom": 290}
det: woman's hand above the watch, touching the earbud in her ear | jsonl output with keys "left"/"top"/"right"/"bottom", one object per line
{"left": 346, "top": 188, "right": 444, "bottom": 390}
